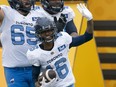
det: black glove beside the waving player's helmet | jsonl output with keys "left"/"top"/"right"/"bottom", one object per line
{"left": 54, "top": 14, "right": 67, "bottom": 32}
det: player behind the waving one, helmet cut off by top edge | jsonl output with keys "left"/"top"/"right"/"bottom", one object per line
{"left": 40, "top": 0, "right": 78, "bottom": 36}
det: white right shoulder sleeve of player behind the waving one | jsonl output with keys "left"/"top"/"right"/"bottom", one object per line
{"left": 62, "top": 6, "right": 75, "bottom": 22}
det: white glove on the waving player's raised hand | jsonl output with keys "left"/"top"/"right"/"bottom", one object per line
{"left": 77, "top": 4, "right": 93, "bottom": 21}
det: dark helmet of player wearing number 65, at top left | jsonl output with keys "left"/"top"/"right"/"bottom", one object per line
{"left": 8, "top": 0, "right": 35, "bottom": 13}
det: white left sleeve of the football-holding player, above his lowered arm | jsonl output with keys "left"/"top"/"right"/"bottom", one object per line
{"left": 27, "top": 50, "right": 40, "bottom": 66}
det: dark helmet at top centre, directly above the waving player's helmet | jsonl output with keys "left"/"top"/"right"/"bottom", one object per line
{"left": 41, "top": 0, "right": 64, "bottom": 14}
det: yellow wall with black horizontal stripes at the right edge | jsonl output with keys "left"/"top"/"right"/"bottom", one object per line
{"left": 88, "top": 0, "right": 116, "bottom": 87}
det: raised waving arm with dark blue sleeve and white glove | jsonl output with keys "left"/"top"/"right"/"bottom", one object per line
{"left": 70, "top": 4, "right": 93, "bottom": 47}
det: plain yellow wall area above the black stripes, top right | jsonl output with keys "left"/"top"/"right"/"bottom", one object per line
{"left": 88, "top": 0, "right": 116, "bottom": 20}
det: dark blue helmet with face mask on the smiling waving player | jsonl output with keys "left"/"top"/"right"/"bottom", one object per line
{"left": 34, "top": 17, "right": 57, "bottom": 43}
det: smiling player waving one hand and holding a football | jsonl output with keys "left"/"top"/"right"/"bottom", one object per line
{"left": 27, "top": 4, "right": 93, "bottom": 87}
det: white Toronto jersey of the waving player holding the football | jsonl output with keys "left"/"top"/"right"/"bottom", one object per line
{"left": 27, "top": 32, "right": 75, "bottom": 87}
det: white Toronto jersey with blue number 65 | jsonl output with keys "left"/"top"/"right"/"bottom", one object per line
{"left": 0, "top": 6, "right": 41, "bottom": 67}
